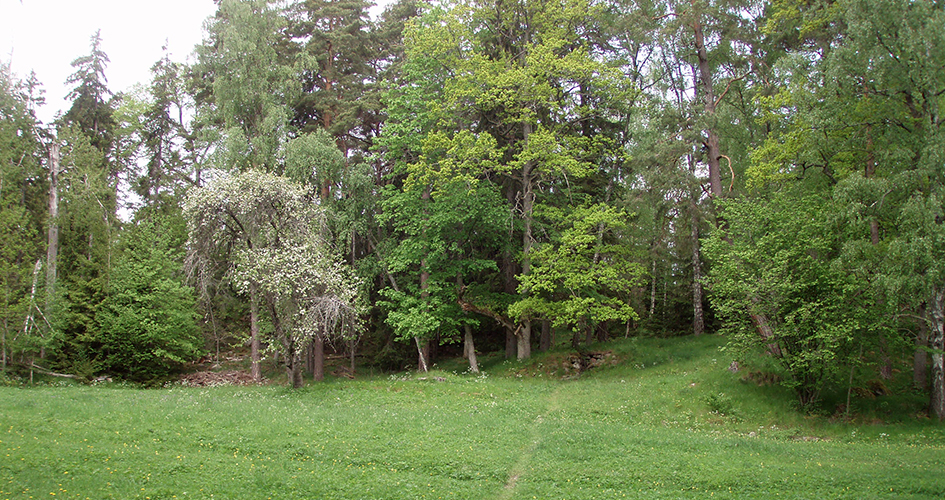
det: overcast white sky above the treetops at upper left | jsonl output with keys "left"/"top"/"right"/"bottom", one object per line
{"left": 0, "top": 0, "right": 389, "bottom": 123}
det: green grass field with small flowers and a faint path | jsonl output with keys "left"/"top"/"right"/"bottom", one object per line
{"left": 0, "top": 336, "right": 945, "bottom": 499}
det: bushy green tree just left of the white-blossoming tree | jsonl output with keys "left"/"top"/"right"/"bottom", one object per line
{"left": 95, "top": 216, "right": 203, "bottom": 382}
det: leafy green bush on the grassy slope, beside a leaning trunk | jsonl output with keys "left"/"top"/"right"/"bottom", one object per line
{"left": 705, "top": 192, "right": 875, "bottom": 406}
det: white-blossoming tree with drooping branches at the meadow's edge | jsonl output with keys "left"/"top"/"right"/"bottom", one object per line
{"left": 184, "top": 170, "right": 360, "bottom": 387}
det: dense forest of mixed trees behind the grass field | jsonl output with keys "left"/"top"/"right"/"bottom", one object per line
{"left": 0, "top": 0, "right": 945, "bottom": 419}
